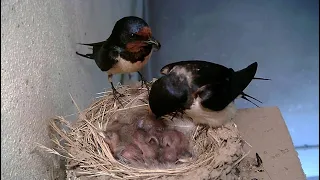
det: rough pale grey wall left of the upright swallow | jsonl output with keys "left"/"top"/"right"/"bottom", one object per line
{"left": 1, "top": 0, "right": 142, "bottom": 180}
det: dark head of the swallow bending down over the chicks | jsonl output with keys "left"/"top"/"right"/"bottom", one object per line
{"left": 149, "top": 74, "right": 189, "bottom": 118}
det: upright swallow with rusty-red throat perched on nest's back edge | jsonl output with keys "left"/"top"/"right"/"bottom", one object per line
{"left": 76, "top": 16, "right": 161, "bottom": 101}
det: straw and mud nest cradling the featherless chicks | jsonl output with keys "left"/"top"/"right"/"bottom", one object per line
{"left": 38, "top": 81, "right": 249, "bottom": 180}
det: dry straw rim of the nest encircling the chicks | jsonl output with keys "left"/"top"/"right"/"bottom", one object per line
{"left": 42, "top": 83, "right": 250, "bottom": 179}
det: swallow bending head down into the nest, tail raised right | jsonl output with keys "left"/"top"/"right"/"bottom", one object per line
{"left": 149, "top": 60, "right": 269, "bottom": 128}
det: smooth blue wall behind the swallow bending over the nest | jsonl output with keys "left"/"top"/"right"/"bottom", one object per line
{"left": 146, "top": 0, "right": 319, "bottom": 176}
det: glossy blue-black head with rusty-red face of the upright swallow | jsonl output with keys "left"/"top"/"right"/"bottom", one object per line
{"left": 111, "top": 16, "right": 161, "bottom": 52}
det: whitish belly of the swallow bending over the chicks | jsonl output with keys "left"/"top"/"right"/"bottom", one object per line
{"left": 185, "top": 97, "right": 237, "bottom": 128}
